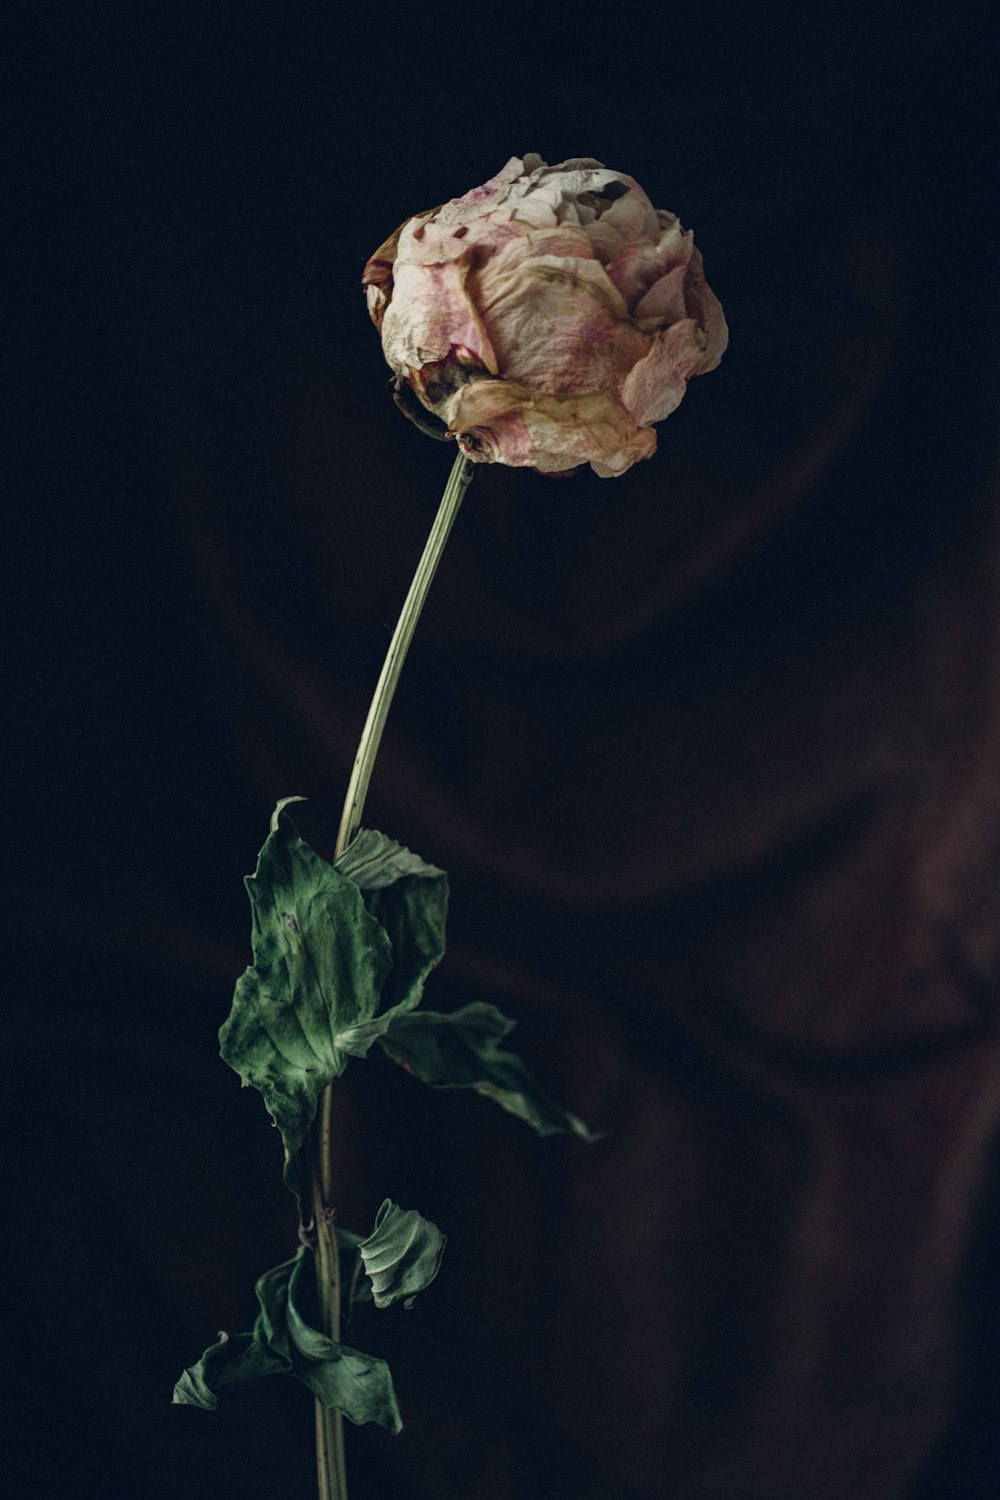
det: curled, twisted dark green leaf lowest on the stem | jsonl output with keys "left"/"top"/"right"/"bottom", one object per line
{"left": 174, "top": 1245, "right": 403, "bottom": 1433}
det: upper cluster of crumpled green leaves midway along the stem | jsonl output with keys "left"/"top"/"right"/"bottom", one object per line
{"left": 219, "top": 798, "right": 594, "bottom": 1203}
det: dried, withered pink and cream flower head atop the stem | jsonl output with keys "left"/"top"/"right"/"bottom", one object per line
{"left": 364, "top": 155, "right": 729, "bottom": 477}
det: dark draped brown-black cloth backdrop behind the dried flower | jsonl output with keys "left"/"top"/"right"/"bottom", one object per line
{"left": 4, "top": 3, "right": 1000, "bottom": 1500}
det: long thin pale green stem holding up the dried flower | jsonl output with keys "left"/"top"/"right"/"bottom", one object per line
{"left": 312, "top": 453, "right": 474, "bottom": 1500}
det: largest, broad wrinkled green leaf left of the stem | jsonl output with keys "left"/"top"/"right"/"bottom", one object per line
{"left": 219, "top": 798, "right": 393, "bottom": 1158}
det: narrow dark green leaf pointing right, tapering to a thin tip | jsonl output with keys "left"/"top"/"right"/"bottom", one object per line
{"left": 374, "top": 1001, "right": 600, "bottom": 1142}
